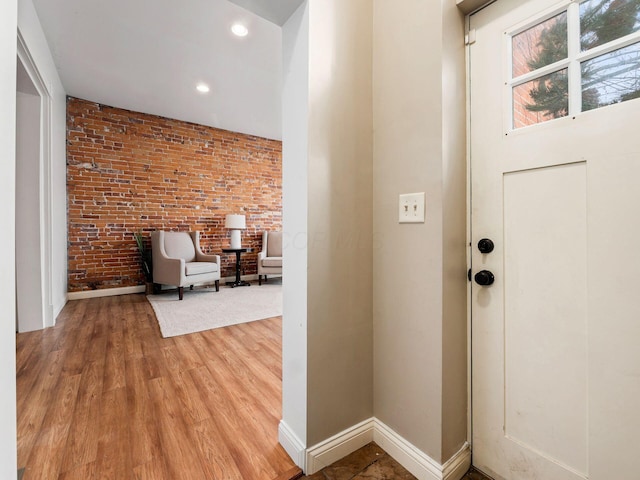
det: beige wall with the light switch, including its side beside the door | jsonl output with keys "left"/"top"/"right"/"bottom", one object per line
{"left": 373, "top": 0, "right": 467, "bottom": 463}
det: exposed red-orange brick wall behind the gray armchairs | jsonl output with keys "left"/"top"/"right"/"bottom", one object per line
{"left": 67, "top": 97, "right": 282, "bottom": 291}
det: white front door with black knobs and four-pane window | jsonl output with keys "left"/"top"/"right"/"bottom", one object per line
{"left": 469, "top": 0, "right": 640, "bottom": 480}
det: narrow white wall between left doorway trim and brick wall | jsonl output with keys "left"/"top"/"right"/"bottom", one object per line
{"left": 14, "top": 0, "right": 67, "bottom": 321}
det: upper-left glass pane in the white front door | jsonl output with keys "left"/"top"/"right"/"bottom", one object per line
{"left": 511, "top": 11, "right": 568, "bottom": 78}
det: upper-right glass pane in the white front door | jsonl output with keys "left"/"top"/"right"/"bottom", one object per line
{"left": 580, "top": 0, "right": 640, "bottom": 51}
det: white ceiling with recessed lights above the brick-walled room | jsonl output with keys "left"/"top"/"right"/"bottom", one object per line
{"left": 34, "top": 0, "right": 303, "bottom": 139}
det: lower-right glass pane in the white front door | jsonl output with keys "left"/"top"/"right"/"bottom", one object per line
{"left": 581, "top": 43, "right": 640, "bottom": 112}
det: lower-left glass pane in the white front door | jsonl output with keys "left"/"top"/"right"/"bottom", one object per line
{"left": 513, "top": 68, "right": 569, "bottom": 128}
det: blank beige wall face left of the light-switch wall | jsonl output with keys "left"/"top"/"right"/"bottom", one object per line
{"left": 307, "top": 0, "right": 374, "bottom": 446}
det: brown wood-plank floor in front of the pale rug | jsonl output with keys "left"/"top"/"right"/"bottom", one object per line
{"left": 17, "top": 295, "right": 299, "bottom": 480}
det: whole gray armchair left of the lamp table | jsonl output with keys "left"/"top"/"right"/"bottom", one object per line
{"left": 151, "top": 230, "right": 220, "bottom": 300}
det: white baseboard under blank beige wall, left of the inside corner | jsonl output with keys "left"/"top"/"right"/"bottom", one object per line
{"left": 305, "top": 418, "right": 374, "bottom": 475}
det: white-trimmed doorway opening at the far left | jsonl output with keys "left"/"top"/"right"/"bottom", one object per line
{"left": 15, "top": 35, "right": 54, "bottom": 332}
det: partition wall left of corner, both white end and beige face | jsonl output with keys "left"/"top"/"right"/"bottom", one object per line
{"left": 283, "top": 0, "right": 373, "bottom": 462}
